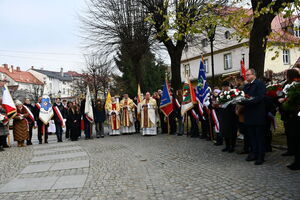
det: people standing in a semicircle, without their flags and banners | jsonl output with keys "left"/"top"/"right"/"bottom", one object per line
{"left": 0, "top": 69, "right": 300, "bottom": 170}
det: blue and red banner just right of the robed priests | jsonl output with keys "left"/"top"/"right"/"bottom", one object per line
{"left": 159, "top": 80, "right": 173, "bottom": 117}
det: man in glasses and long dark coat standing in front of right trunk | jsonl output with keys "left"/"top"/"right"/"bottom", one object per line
{"left": 241, "top": 69, "right": 267, "bottom": 165}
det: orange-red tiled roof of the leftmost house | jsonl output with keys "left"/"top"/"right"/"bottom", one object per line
{"left": 0, "top": 66, "right": 43, "bottom": 85}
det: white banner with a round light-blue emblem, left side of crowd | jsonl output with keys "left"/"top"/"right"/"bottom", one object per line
{"left": 39, "top": 95, "right": 54, "bottom": 125}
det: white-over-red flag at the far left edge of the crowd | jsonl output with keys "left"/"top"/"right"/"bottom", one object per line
{"left": 2, "top": 85, "right": 17, "bottom": 119}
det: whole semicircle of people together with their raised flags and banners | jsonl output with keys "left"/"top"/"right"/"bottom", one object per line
{"left": 0, "top": 61, "right": 300, "bottom": 170}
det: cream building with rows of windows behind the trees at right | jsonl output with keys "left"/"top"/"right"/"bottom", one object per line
{"left": 181, "top": 16, "right": 300, "bottom": 80}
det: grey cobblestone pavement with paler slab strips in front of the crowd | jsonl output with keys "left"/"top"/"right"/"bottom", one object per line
{"left": 0, "top": 131, "right": 300, "bottom": 200}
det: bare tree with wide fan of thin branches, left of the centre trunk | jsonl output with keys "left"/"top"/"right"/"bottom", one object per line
{"left": 82, "top": 0, "right": 155, "bottom": 86}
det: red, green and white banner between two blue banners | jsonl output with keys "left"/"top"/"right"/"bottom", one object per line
{"left": 181, "top": 79, "right": 197, "bottom": 116}
